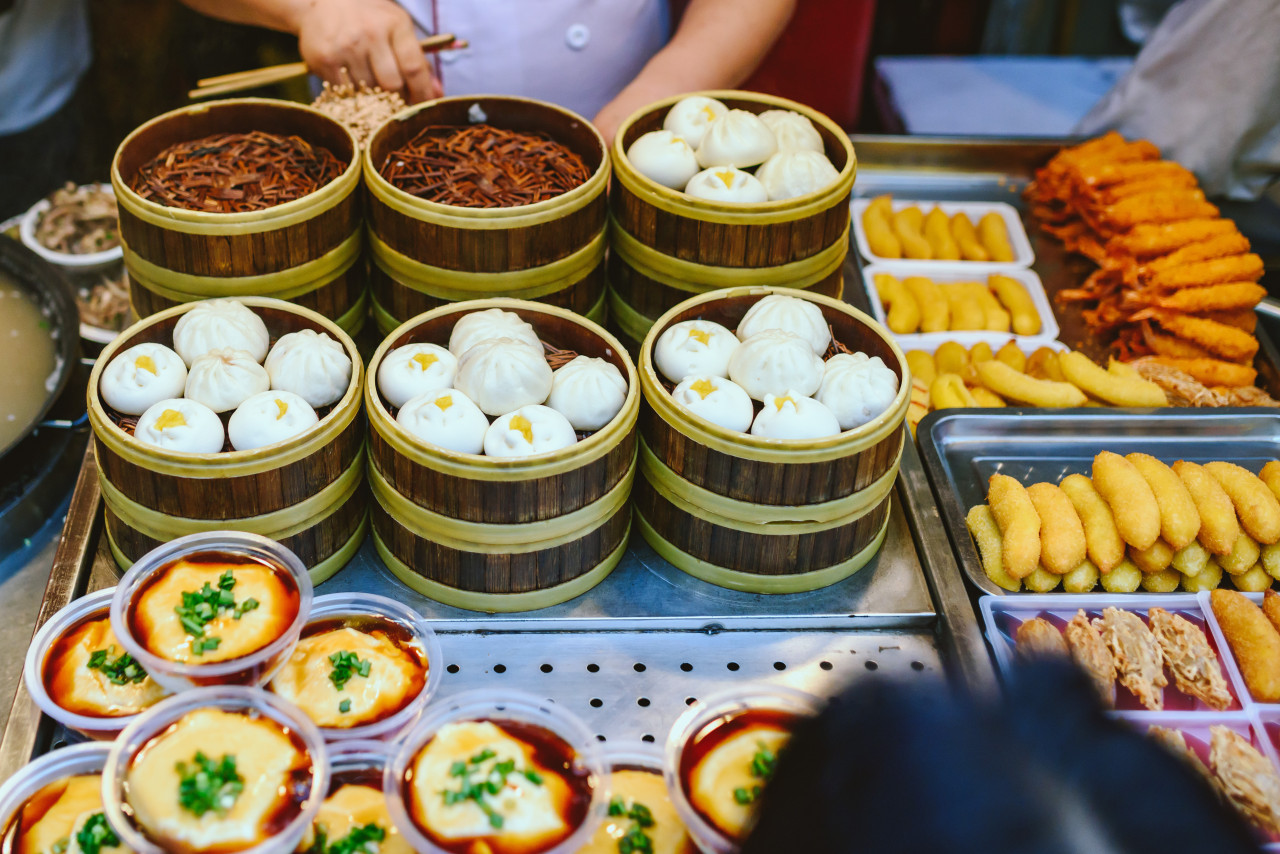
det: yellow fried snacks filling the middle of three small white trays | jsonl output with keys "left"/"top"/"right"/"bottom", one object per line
{"left": 874, "top": 273, "right": 1043, "bottom": 335}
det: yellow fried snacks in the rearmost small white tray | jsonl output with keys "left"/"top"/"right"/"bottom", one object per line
{"left": 863, "top": 196, "right": 1014, "bottom": 264}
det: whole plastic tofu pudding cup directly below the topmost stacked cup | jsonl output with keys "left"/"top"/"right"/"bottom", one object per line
{"left": 102, "top": 685, "right": 329, "bottom": 854}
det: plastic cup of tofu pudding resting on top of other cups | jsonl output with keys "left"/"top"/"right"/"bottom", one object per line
{"left": 111, "top": 531, "right": 312, "bottom": 691}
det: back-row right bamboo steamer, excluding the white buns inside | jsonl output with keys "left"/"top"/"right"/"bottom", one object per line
{"left": 609, "top": 91, "right": 858, "bottom": 352}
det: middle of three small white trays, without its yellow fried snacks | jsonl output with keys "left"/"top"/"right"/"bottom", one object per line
{"left": 863, "top": 261, "right": 1061, "bottom": 352}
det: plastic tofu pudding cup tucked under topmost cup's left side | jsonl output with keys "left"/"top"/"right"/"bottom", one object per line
{"left": 22, "top": 588, "right": 168, "bottom": 740}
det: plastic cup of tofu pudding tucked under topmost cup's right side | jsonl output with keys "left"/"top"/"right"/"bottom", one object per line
{"left": 266, "top": 593, "right": 444, "bottom": 741}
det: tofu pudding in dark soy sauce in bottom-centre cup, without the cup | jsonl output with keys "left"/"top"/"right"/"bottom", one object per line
{"left": 403, "top": 720, "right": 593, "bottom": 854}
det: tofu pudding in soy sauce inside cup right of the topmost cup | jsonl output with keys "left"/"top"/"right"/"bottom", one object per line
{"left": 268, "top": 615, "right": 430, "bottom": 729}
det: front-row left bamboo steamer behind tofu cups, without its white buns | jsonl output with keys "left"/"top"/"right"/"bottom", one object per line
{"left": 88, "top": 297, "right": 369, "bottom": 584}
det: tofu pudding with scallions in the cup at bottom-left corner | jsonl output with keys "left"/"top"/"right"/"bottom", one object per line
{"left": 3, "top": 773, "right": 132, "bottom": 854}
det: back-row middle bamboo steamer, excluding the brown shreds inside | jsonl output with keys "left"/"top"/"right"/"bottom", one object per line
{"left": 364, "top": 96, "right": 609, "bottom": 334}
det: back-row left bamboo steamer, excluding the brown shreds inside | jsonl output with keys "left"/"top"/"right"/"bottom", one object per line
{"left": 111, "top": 97, "right": 367, "bottom": 334}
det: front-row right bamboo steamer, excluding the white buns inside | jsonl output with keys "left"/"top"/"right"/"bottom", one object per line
{"left": 634, "top": 288, "right": 911, "bottom": 593}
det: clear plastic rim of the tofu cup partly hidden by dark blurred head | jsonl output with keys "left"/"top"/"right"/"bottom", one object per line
{"left": 663, "top": 685, "right": 823, "bottom": 854}
